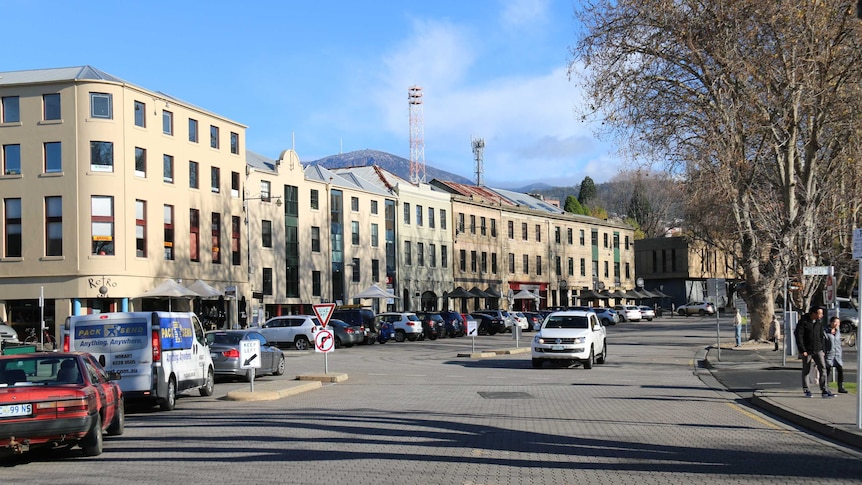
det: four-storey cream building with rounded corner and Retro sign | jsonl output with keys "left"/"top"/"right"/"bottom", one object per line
{"left": 0, "top": 66, "right": 247, "bottom": 336}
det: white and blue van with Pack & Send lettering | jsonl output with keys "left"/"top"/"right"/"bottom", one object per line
{"left": 63, "top": 312, "right": 214, "bottom": 411}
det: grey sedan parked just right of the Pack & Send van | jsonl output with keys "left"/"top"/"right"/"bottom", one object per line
{"left": 206, "top": 329, "right": 285, "bottom": 381}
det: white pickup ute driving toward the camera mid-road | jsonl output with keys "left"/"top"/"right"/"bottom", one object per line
{"left": 530, "top": 310, "right": 608, "bottom": 369}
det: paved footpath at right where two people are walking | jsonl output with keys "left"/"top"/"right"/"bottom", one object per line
{"left": 697, "top": 342, "right": 862, "bottom": 449}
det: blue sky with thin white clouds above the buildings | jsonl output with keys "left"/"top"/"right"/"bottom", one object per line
{"left": 0, "top": 0, "right": 622, "bottom": 187}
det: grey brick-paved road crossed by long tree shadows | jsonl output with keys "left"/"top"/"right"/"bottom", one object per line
{"left": 2, "top": 317, "right": 862, "bottom": 484}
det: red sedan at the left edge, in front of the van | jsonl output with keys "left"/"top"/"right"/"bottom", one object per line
{"left": 0, "top": 352, "right": 125, "bottom": 456}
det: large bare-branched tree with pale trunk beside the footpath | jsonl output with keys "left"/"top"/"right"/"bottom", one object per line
{"left": 569, "top": 0, "right": 862, "bottom": 339}
